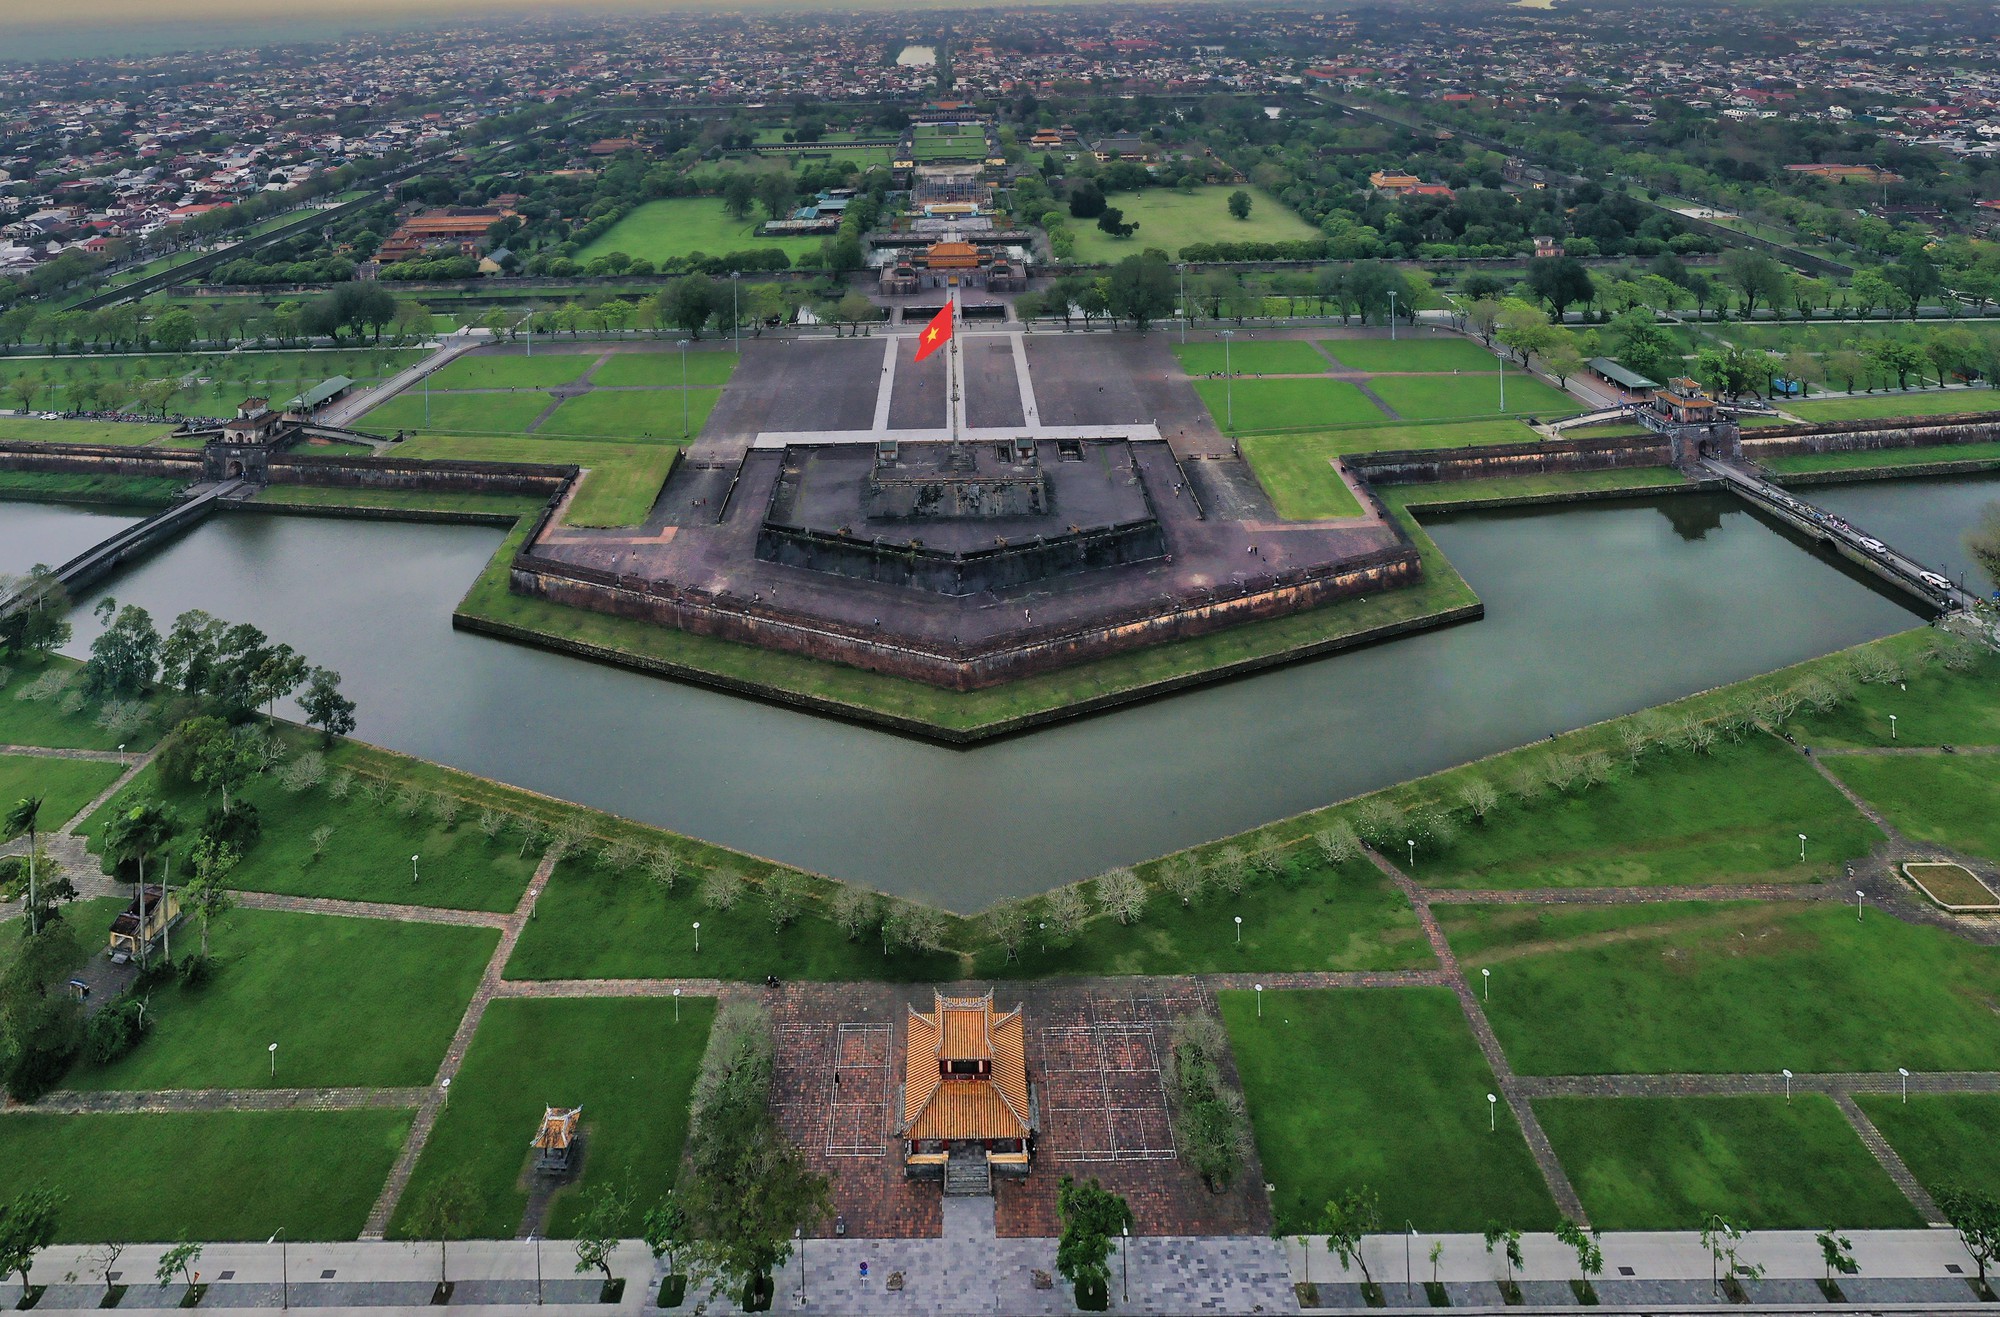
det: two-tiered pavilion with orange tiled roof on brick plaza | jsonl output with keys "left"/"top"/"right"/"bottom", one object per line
{"left": 900, "top": 993, "right": 1036, "bottom": 1179}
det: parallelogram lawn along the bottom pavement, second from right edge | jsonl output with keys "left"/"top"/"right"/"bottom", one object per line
{"left": 1534, "top": 1093, "right": 1922, "bottom": 1231}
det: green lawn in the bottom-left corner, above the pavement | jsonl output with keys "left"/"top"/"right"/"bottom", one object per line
{"left": 0, "top": 1109, "right": 410, "bottom": 1240}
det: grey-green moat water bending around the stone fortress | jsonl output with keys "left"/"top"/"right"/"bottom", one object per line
{"left": 0, "top": 478, "right": 2000, "bottom": 911}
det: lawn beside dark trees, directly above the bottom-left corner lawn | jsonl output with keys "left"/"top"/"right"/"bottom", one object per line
{"left": 68, "top": 911, "right": 500, "bottom": 1089}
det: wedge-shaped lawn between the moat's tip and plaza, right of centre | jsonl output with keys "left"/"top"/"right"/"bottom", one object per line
{"left": 974, "top": 847, "right": 1436, "bottom": 979}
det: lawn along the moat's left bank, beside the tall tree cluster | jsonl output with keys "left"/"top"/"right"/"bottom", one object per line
{"left": 82, "top": 737, "right": 540, "bottom": 911}
